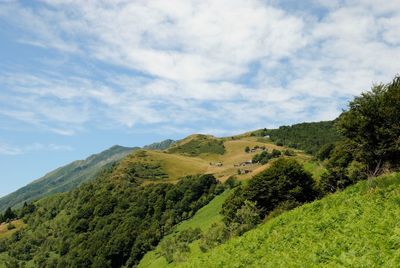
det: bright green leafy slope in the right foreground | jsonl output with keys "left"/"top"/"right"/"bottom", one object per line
{"left": 177, "top": 173, "right": 400, "bottom": 267}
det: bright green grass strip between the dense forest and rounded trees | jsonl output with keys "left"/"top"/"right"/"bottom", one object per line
{"left": 138, "top": 190, "right": 231, "bottom": 268}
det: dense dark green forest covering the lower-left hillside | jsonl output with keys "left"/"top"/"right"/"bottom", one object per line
{"left": 0, "top": 167, "right": 220, "bottom": 267}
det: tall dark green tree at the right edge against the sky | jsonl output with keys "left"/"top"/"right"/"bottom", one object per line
{"left": 337, "top": 77, "right": 400, "bottom": 175}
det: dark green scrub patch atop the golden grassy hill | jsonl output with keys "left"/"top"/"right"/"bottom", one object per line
{"left": 168, "top": 135, "right": 225, "bottom": 156}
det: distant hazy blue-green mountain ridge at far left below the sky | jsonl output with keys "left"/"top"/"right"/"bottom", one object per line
{"left": 0, "top": 145, "right": 139, "bottom": 211}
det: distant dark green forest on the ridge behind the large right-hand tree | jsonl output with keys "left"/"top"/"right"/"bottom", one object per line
{"left": 254, "top": 121, "right": 343, "bottom": 155}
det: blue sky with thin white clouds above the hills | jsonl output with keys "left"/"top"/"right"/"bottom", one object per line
{"left": 0, "top": 0, "right": 400, "bottom": 196}
